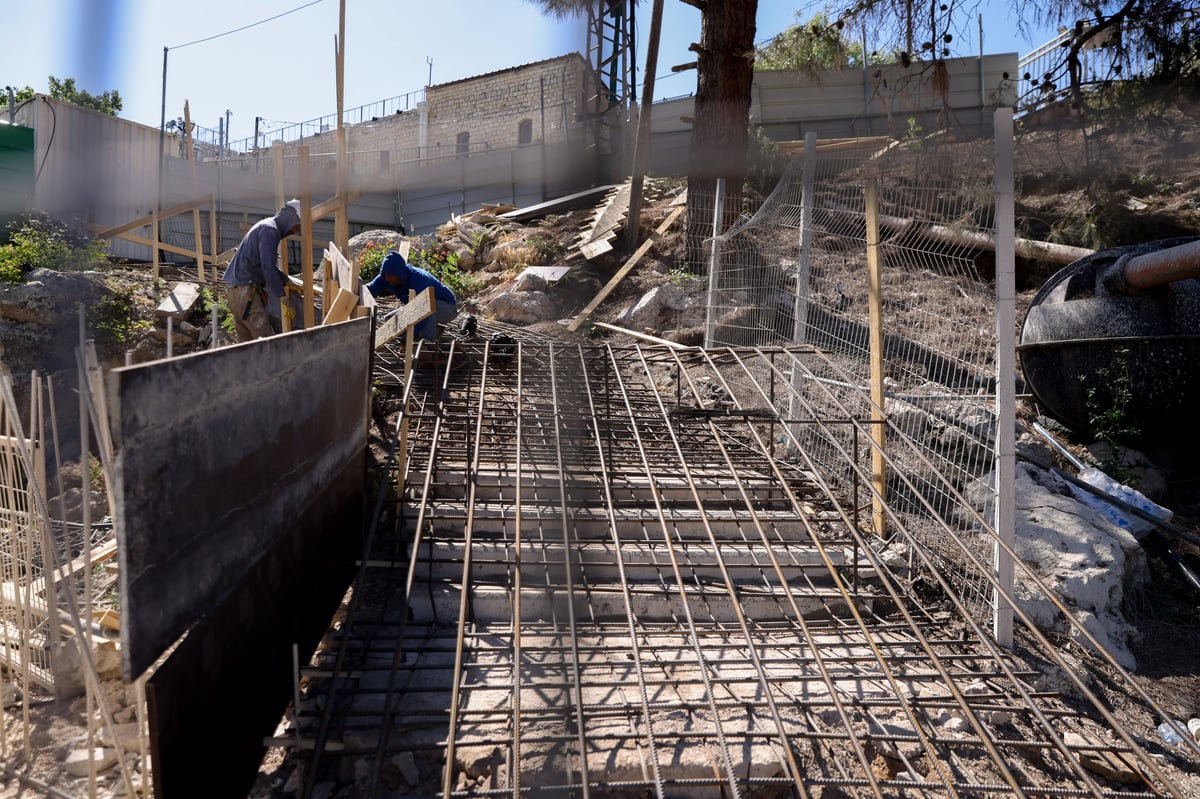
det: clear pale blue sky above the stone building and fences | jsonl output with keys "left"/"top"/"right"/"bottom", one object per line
{"left": 0, "top": 0, "right": 1048, "bottom": 140}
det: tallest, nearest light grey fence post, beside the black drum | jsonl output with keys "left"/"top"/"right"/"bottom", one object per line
{"left": 992, "top": 108, "right": 1016, "bottom": 648}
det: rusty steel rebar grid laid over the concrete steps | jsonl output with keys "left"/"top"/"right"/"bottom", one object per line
{"left": 281, "top": 341, "right": 1183, "bottom": 798}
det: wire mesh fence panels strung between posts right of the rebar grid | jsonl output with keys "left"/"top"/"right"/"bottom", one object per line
{"left": 707, "top": 137, "right": 996, "bottom": 618}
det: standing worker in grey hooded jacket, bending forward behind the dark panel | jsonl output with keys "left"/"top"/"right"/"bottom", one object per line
{"left": 224, "top": 200, "right": 300, "bottom": 342}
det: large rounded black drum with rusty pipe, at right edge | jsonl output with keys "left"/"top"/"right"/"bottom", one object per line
{"left": 1016, "top": 236, "right": 1200, "bottom": 447}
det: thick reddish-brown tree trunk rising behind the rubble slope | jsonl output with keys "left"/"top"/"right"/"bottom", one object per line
{"left": 688, "top": 0, "right": 758, "bottom": 275}
